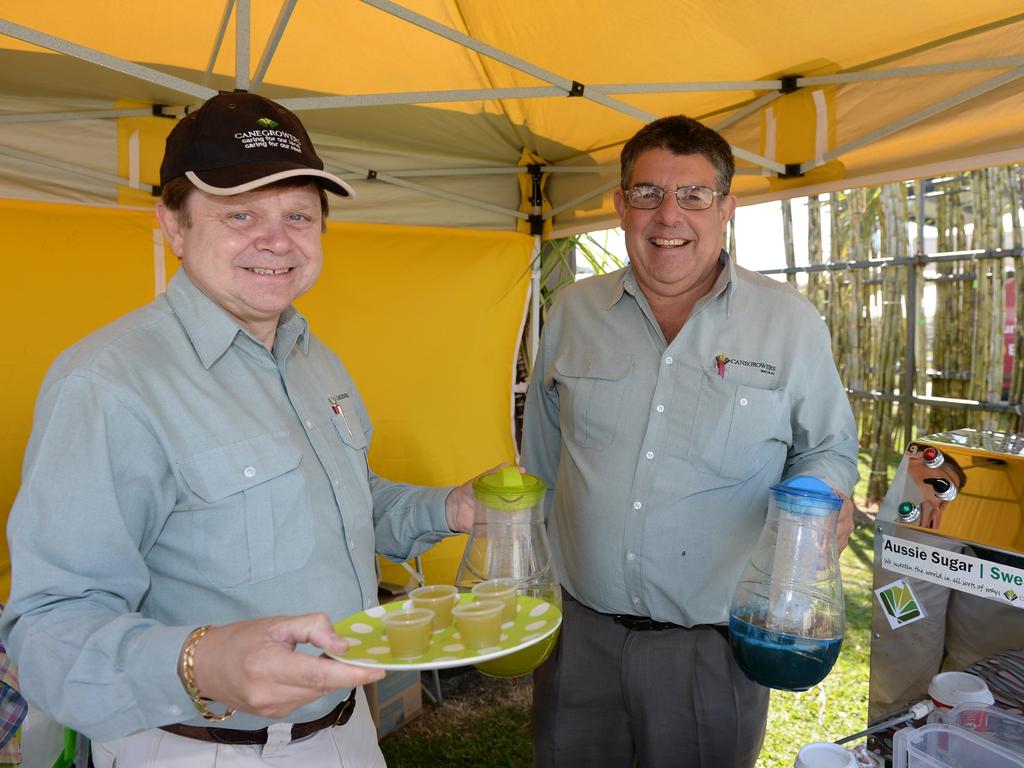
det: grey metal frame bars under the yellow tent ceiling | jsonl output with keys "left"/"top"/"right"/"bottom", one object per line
{"left": 0, "top": 8, "right": 1024, "bottom": 231}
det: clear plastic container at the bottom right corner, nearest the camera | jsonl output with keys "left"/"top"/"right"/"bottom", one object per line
{"left": 893, "top": 723, "right": 1024, "bottom": 768}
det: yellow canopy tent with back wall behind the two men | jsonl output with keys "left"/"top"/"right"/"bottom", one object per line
{"left": 0, "top": 0, "right": 1024, "bottom": 598}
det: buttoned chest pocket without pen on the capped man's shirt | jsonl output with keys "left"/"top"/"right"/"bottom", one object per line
{"left": 176, "top": 432, "right": 313, "bottom": 588}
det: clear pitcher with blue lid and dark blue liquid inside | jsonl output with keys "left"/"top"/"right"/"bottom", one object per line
{"left": 729, "top": 476, "right": 845, "bottom": 691}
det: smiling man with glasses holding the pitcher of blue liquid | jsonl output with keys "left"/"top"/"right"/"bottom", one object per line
{"left": 522, "top": 117, "right": 857, "bottom": 768}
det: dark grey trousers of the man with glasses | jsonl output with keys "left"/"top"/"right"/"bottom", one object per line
{"left": 534, "top": 592, "right": 769, "bottom": 768}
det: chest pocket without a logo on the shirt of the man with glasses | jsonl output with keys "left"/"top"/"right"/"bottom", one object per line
{"left": 555, "top": 350, "right": 633, "bottom": 451}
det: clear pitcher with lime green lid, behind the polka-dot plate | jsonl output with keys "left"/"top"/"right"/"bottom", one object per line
{"left": 455, "top": 467, "right": 562, "bottom": 677}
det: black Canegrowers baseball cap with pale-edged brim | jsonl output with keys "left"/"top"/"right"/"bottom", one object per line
{"left": 160, "top": 92, "right": 355, "bottom": 198}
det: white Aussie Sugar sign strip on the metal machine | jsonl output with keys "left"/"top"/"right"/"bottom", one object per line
{"left": 882, "top": 536, "right": 1024, "bottom": 608}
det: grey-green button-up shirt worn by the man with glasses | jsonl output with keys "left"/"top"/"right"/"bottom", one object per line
{"left": 522, "top": 252, "right": 857, "bottom": 626}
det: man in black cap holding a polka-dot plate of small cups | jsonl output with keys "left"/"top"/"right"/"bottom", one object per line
{"left": 0, "top": 93, "right": 472, "bottom": 766}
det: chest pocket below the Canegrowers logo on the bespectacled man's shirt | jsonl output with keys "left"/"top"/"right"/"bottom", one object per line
{"left": 689, "top": 371, "right": 793, "bottom": 481}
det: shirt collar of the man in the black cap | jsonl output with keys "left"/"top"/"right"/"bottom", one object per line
{"left": 161, "top": 269, "right": 309, "bottom": 369}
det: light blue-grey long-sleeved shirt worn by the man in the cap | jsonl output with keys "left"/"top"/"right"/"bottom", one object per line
{"left": 0, "top": 271, "right": 451, "bottom": 740}
